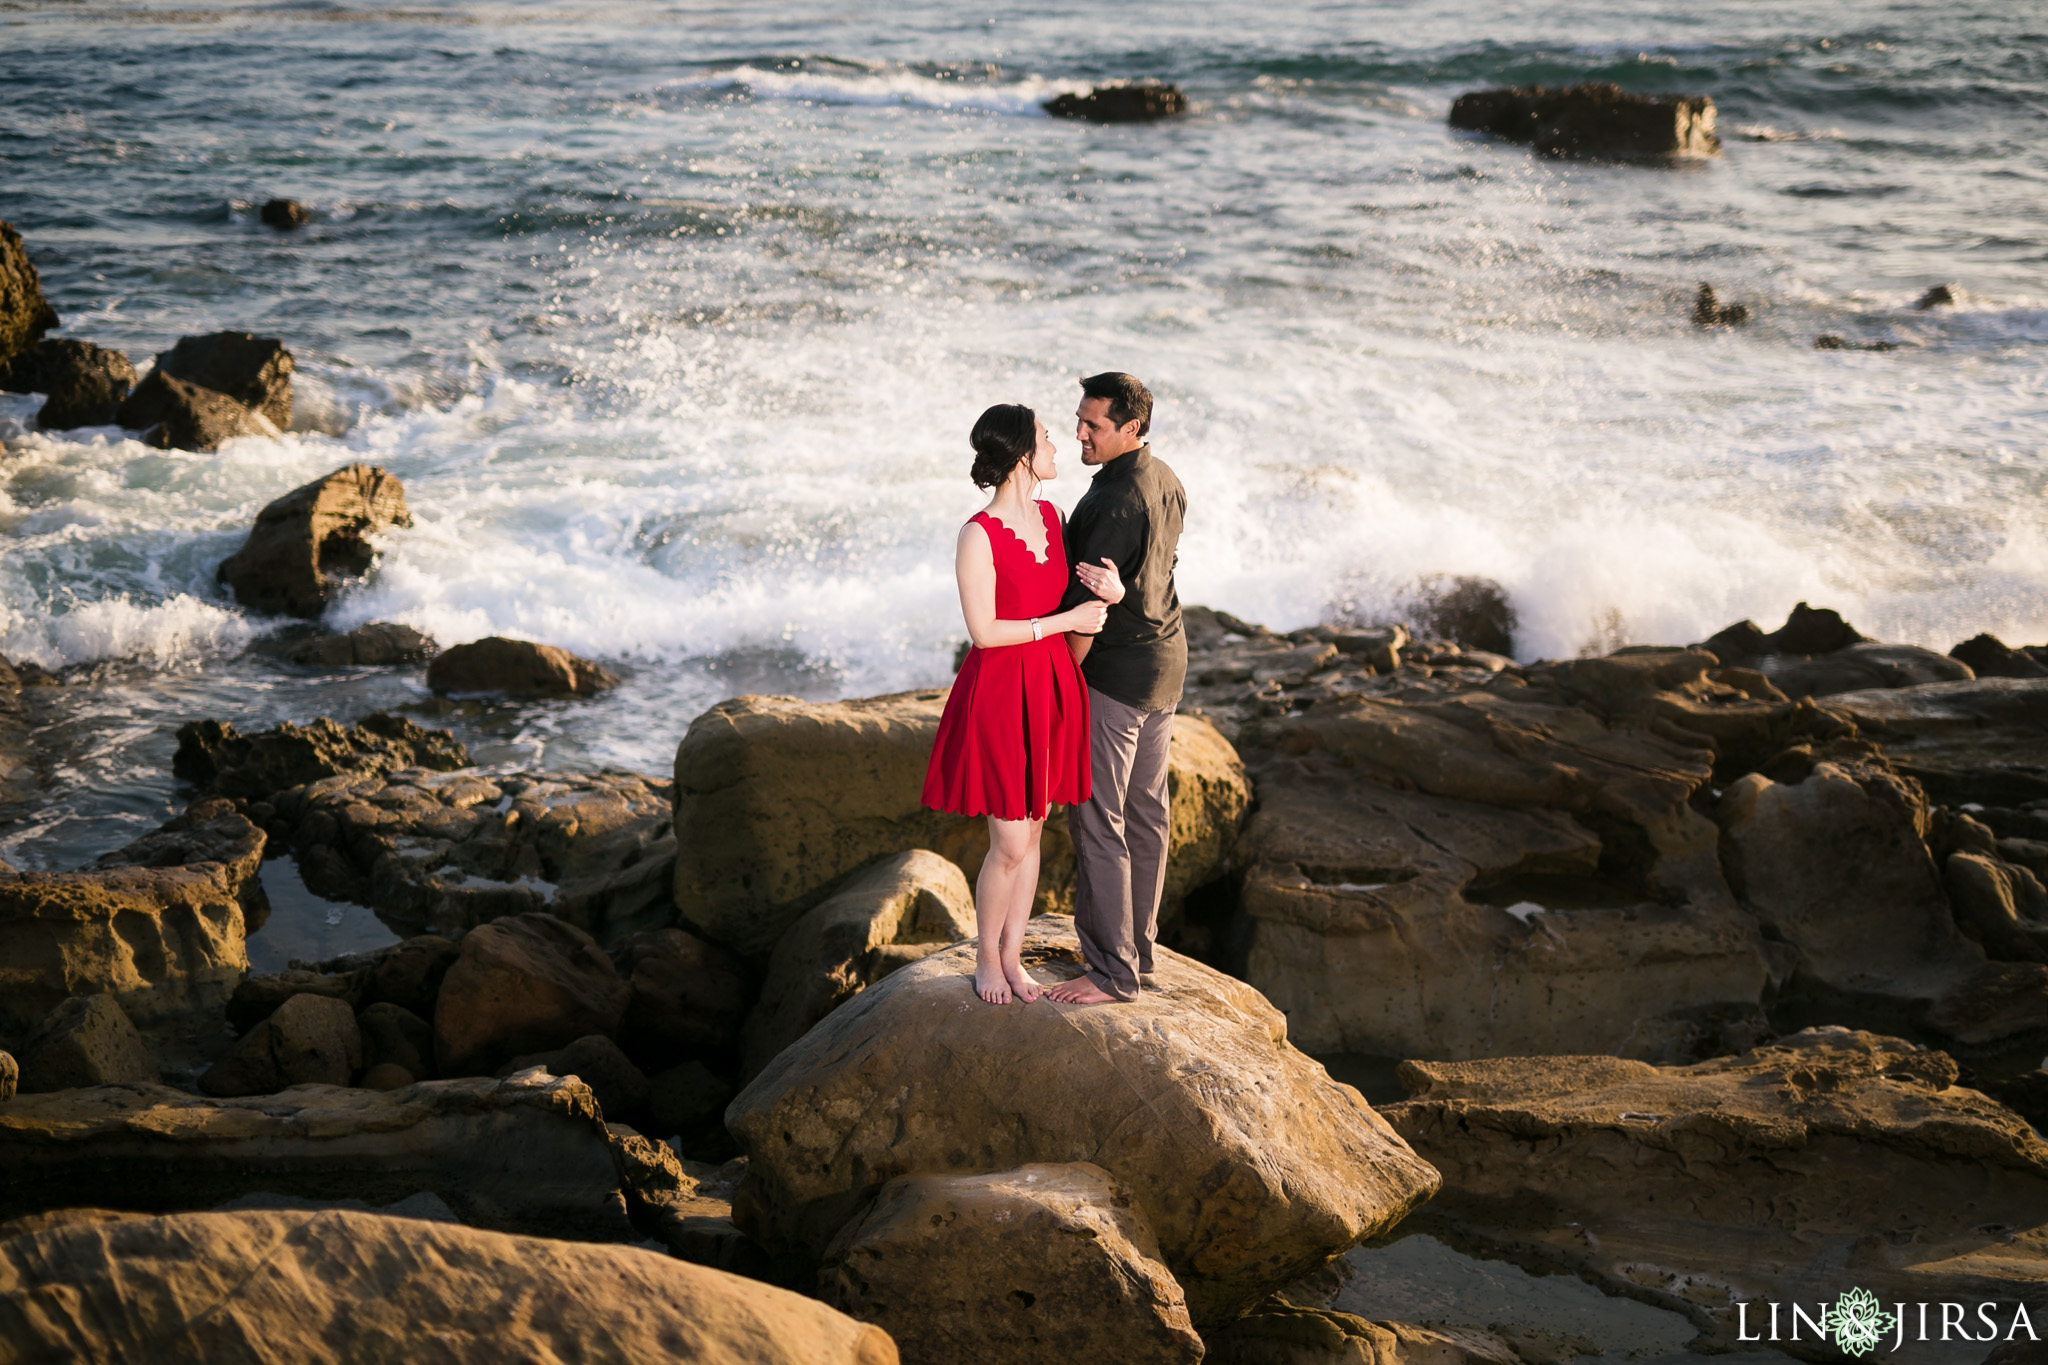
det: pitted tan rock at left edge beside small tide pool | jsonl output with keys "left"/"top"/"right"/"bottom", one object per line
{"left": 0, "top": 843, "right": 262, "bottom": 1031}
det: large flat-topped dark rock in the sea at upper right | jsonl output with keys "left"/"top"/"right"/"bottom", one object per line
{"left": 1450, "top": 82, "right": 1720, "bottom": 160}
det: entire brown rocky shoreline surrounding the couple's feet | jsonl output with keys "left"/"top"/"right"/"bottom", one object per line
{"left": 0, "top": 218, "right": 2048, "bottom": 1365}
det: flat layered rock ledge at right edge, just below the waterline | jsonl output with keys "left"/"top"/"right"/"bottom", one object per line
{"left": 1825, "top": 677, "right": 2048, "bottom": 808}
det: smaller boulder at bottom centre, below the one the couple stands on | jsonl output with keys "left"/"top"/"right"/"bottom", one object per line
{"left": 819, "top": 1162, "right": 1202, "bottom": 1365}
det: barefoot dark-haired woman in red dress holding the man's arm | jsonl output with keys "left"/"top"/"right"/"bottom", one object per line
{"left": 924, "top": 403, "right": 1124, "bottom": 1005}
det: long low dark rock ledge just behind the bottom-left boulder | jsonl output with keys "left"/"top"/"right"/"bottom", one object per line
{"left": 0, "top": 1070, "right": 688, "bottom": 1240}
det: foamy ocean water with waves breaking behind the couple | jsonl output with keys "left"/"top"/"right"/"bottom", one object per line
{"left": 0, "top": 0, "right": 2048, "bottom": 866}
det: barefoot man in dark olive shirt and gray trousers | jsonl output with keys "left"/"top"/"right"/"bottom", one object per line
{"left": 1047, "top": 375, "right": 1188, "bottom": 1005}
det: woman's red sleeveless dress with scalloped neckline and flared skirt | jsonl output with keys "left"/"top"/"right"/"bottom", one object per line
{"left": 924, "top": 501, "right": 1087, "bottom": 821}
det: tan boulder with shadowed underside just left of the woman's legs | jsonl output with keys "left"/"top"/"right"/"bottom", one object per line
{"left": 739, "top": 849, "right": 975, "bottom": 1076}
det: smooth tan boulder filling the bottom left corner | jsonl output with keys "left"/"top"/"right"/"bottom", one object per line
{"left": 0, "top": 1209, "right": 897, "bottom": 1365}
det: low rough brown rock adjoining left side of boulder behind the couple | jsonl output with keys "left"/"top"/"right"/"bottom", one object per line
{"left": 274, "top": 769, "right": 676, "bottom": 943}
